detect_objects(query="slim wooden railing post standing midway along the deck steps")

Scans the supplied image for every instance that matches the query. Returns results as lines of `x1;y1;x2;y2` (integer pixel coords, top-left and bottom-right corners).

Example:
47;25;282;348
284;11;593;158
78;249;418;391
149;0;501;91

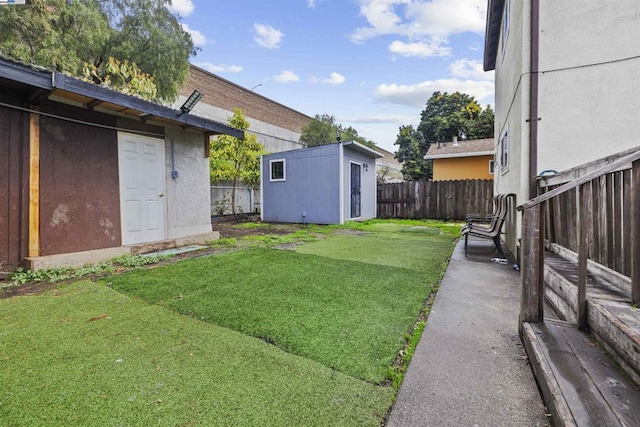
576;182;593;330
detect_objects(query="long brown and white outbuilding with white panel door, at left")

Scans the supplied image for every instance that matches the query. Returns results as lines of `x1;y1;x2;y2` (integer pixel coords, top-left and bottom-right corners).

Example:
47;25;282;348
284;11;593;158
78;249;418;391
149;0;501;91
0;58;244;272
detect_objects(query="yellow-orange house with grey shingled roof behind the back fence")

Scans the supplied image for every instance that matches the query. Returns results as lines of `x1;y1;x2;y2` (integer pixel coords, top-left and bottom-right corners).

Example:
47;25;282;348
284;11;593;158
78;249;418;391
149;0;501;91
424;138;494;181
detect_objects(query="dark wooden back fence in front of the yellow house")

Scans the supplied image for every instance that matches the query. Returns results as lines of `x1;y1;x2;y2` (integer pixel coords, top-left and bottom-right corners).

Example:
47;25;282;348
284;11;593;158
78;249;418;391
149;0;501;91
378;179;493;220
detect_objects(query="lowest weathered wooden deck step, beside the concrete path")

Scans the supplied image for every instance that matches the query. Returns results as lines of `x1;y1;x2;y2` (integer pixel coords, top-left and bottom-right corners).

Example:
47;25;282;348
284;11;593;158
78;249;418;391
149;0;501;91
523;320;640;426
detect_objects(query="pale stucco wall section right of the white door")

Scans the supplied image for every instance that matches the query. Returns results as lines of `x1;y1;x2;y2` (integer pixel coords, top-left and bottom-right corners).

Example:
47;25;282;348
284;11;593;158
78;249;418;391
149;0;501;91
165;126;211;239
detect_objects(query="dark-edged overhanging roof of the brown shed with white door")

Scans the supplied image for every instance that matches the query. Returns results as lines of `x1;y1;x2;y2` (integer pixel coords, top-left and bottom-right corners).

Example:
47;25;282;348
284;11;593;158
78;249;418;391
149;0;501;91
0;56;244;138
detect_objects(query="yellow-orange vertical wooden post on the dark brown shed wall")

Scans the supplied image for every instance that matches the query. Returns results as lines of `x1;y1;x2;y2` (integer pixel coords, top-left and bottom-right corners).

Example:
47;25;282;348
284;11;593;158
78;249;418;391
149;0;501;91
29;107;40;257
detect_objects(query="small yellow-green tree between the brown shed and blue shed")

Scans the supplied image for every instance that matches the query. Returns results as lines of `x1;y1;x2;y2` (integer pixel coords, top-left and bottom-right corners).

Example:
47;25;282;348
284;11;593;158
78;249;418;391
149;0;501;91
209;108;264;219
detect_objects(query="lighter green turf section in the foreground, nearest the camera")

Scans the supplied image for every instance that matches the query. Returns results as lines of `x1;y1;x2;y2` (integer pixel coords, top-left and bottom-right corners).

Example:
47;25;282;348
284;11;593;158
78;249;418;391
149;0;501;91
0;281;392;427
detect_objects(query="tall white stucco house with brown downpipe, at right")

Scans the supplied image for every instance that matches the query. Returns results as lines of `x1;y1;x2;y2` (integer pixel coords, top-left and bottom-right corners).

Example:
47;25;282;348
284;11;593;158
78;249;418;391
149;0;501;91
484;0;640;253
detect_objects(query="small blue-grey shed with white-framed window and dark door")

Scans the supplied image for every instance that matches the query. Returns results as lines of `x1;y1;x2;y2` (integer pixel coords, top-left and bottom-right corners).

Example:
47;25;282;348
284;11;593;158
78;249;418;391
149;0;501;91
260;141;382;224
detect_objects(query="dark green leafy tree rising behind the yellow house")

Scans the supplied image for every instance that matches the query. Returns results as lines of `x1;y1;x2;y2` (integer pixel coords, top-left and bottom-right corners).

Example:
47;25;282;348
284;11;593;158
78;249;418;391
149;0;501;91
396;92;494;180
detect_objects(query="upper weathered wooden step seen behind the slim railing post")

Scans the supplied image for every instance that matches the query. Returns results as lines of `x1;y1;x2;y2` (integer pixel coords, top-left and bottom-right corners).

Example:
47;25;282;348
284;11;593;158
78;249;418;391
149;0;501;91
545;253;640;386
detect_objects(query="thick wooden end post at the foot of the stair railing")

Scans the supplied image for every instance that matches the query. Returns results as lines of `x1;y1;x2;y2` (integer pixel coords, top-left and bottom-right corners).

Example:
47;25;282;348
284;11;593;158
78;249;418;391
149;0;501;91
520;204;544;323
